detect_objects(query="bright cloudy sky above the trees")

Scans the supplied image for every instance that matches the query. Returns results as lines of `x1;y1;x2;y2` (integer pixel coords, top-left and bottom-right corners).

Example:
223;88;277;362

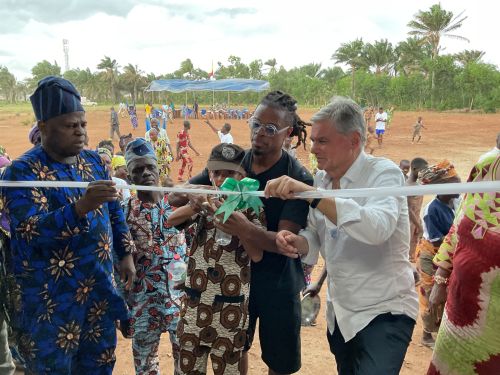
0;0;500;79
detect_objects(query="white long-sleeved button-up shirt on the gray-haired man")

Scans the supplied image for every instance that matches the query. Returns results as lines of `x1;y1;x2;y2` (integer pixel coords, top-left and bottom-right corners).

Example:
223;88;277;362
300;152;418;341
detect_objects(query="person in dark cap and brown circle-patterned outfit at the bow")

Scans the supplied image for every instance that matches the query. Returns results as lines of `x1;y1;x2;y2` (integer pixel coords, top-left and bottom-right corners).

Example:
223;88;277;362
168;143;265;374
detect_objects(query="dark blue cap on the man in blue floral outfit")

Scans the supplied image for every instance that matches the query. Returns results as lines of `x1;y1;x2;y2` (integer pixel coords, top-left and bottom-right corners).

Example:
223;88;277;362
30;76;84;121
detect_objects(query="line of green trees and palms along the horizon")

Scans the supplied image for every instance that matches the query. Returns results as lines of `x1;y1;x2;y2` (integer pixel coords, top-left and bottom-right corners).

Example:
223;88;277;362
0;4;500;112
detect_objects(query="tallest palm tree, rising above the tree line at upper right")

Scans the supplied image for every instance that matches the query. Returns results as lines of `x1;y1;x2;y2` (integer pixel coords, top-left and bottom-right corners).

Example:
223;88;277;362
408;4;469;106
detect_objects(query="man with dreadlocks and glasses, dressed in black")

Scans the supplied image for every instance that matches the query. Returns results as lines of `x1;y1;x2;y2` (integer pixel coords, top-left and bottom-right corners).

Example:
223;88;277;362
170;91;313;375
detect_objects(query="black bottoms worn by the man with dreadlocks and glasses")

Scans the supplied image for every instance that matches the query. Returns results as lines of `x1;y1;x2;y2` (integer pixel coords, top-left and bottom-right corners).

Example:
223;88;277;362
245;289;302;374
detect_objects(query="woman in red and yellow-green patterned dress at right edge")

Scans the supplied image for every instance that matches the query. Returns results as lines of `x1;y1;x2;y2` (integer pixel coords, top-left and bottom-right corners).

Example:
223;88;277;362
427;155;500;375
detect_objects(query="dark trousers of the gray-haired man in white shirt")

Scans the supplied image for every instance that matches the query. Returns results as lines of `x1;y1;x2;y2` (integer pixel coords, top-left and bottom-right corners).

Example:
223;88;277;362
327;313;415;375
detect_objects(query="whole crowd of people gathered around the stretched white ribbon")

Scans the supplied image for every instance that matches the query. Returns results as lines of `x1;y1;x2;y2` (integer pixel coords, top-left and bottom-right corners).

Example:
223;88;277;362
0;77;500;375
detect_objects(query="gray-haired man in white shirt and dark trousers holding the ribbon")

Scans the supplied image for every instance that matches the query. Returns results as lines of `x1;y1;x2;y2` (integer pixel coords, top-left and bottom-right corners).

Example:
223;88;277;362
266;97;418;375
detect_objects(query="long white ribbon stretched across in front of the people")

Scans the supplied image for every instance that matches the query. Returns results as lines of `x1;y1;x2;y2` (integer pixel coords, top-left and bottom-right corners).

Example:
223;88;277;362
0;180;500;198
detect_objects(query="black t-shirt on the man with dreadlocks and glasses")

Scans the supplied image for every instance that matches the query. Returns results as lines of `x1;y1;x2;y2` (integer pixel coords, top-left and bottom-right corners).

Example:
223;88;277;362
189;150;313;294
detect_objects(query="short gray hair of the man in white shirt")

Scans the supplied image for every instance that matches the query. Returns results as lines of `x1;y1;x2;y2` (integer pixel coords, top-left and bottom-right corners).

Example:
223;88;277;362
311;96;366;144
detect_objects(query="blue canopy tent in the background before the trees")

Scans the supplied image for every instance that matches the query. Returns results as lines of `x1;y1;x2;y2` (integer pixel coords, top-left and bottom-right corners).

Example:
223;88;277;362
144;78;270;104
